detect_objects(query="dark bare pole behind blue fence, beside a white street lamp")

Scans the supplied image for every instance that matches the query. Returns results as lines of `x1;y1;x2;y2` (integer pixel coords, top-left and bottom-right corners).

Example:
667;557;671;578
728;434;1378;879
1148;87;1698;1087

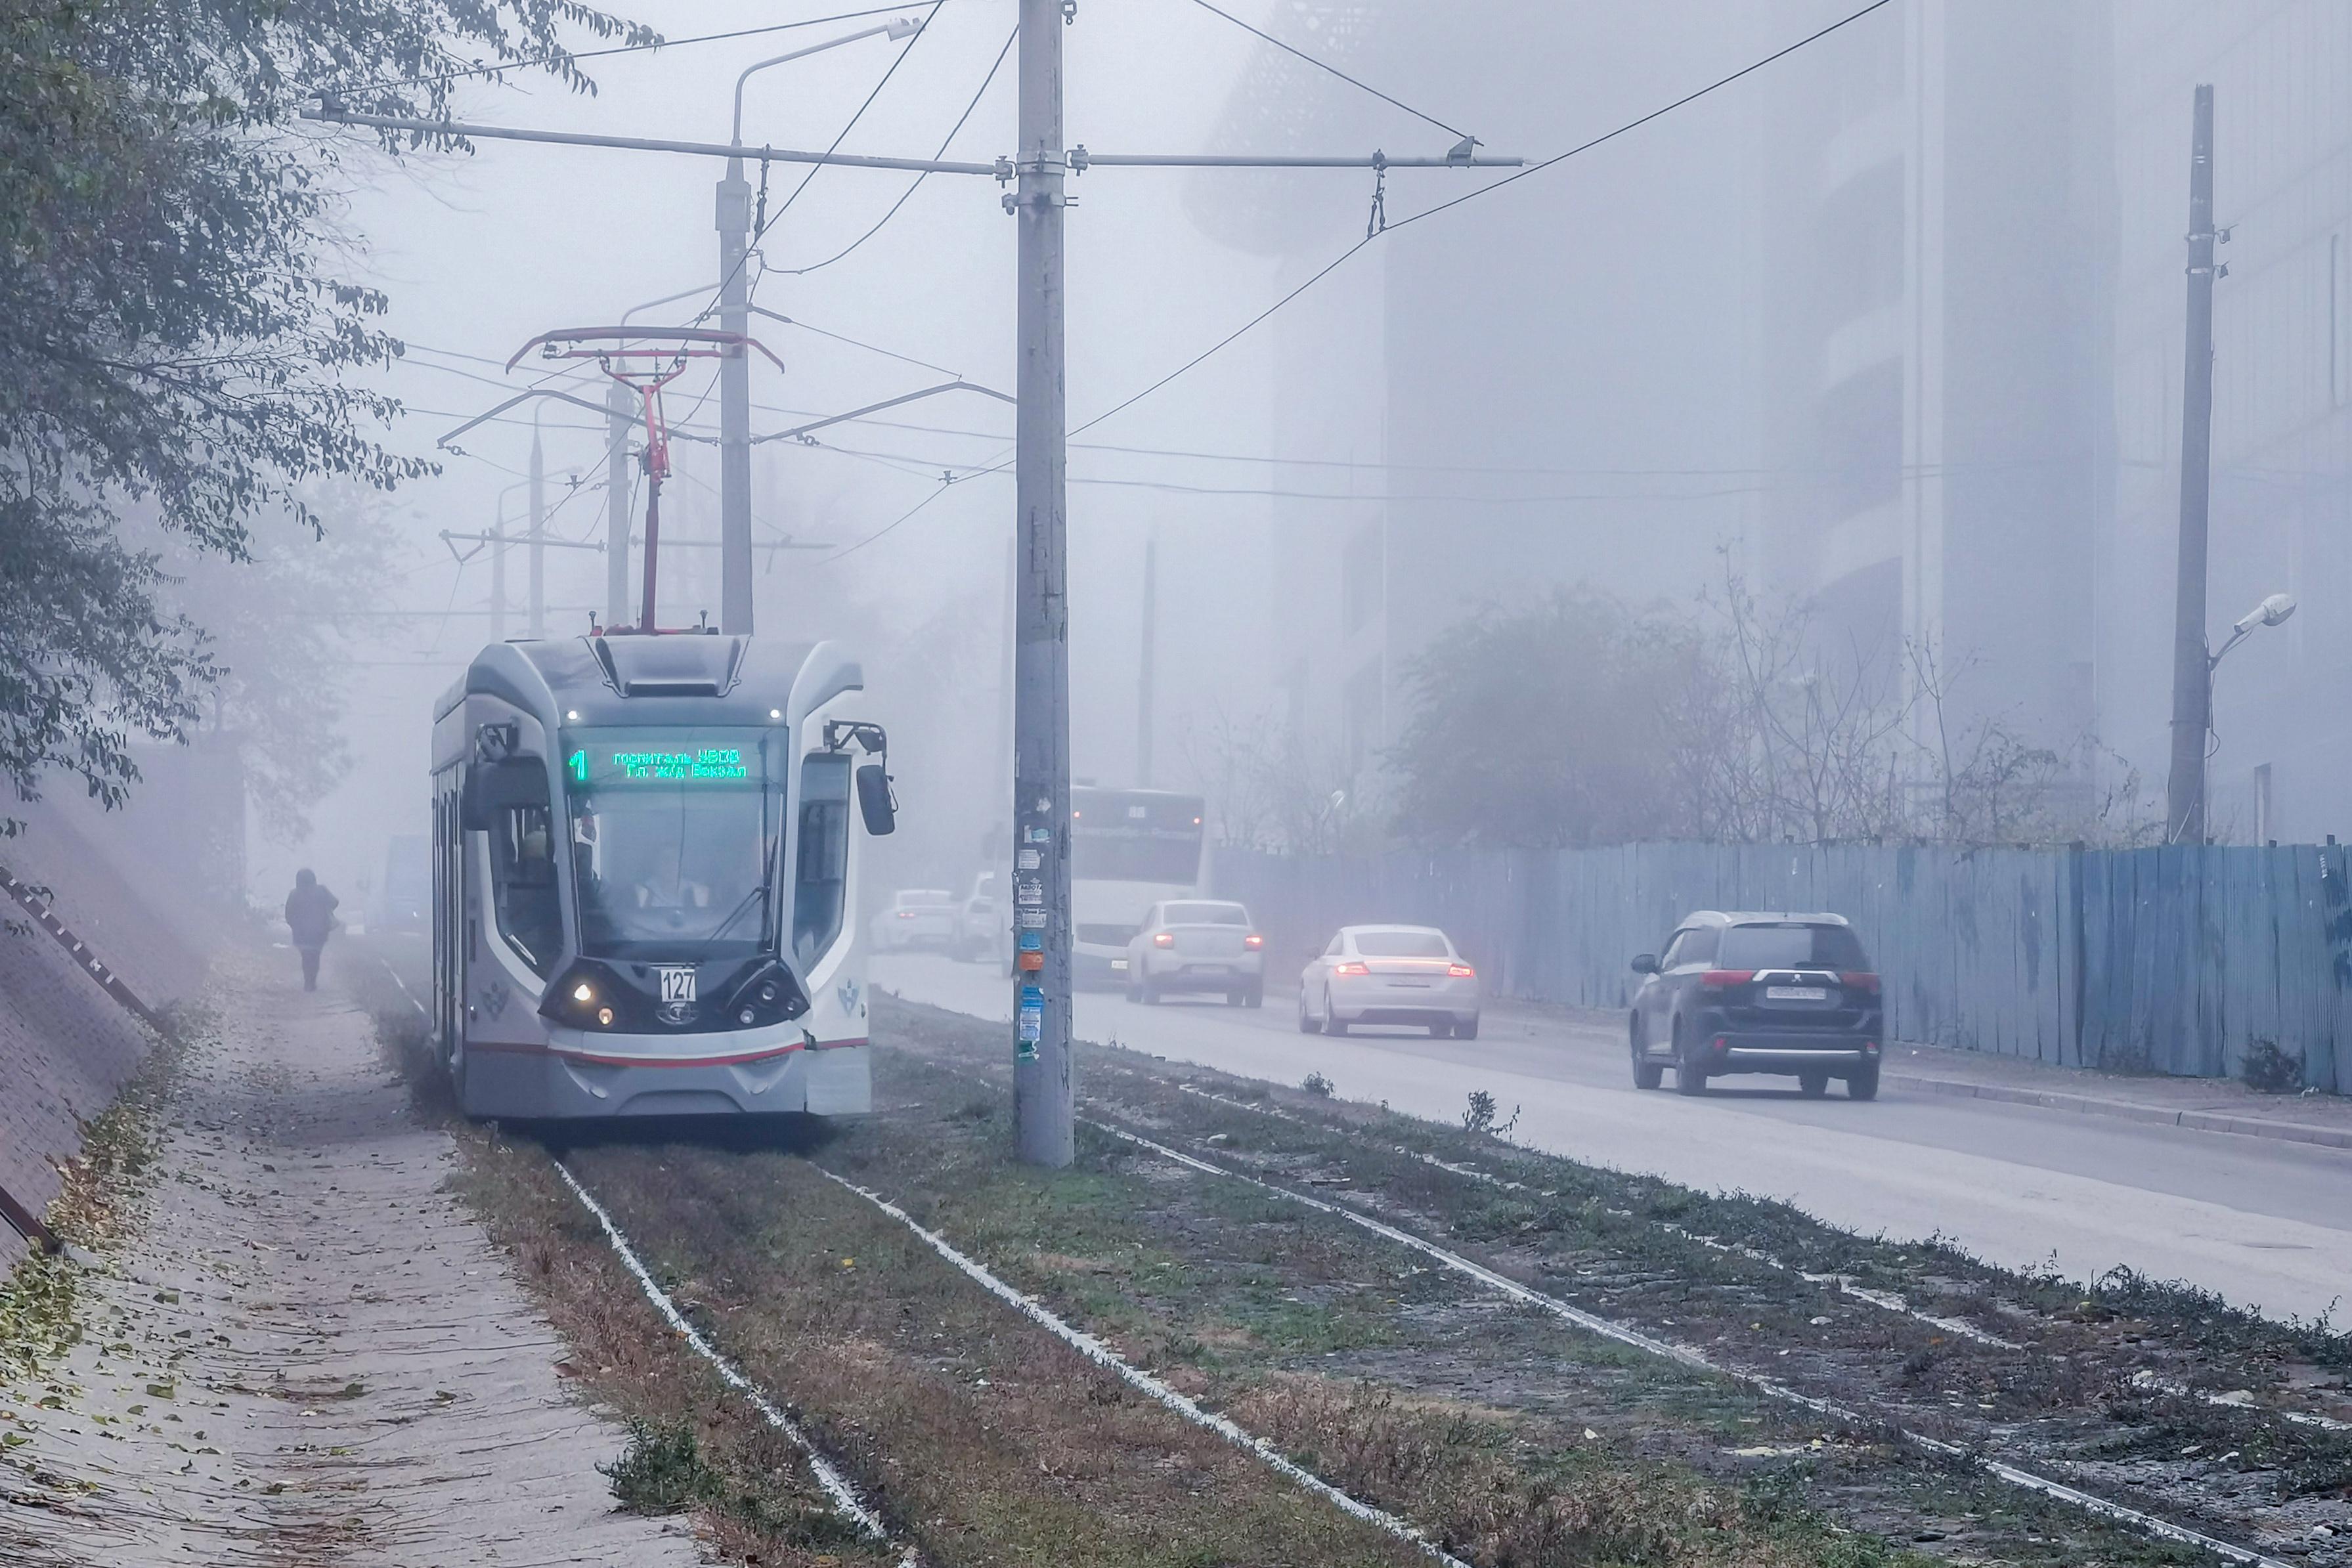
2164;85;2213;844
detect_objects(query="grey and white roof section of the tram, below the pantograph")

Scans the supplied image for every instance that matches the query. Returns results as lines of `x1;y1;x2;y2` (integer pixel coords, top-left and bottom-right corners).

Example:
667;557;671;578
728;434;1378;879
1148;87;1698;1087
433;632;865;724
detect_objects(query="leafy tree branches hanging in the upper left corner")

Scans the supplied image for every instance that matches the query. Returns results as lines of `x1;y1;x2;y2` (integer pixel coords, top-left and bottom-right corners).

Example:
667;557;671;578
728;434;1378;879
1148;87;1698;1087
0;0;649;827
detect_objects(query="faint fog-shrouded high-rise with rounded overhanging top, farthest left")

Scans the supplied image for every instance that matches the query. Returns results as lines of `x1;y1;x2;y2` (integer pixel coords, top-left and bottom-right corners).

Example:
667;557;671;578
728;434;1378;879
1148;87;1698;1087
1188;0;1769;808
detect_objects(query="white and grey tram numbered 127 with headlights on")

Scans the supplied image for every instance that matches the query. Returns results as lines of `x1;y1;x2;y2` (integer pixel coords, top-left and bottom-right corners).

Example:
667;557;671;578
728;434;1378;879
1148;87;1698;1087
433;630;894;1119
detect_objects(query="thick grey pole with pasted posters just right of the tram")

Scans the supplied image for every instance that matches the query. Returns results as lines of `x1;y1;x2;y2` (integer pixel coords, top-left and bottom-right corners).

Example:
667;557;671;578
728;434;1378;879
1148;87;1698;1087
1005;0;1075;1166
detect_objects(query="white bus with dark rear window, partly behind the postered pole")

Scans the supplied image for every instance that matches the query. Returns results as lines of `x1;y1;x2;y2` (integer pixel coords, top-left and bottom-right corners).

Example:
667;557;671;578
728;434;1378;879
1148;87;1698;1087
1070;785;1204;985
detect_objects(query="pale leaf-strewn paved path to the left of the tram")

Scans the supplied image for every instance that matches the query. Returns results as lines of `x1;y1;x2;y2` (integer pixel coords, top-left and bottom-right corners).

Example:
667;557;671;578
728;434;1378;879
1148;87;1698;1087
0;952;701;1568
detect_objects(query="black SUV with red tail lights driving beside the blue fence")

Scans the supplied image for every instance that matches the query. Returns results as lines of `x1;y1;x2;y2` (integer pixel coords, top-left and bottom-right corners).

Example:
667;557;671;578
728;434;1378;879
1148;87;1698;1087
1628;910;1882;1100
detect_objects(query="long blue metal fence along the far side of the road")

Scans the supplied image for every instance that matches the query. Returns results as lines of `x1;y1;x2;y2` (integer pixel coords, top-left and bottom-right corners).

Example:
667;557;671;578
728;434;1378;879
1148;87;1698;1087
1213;844;2352;1093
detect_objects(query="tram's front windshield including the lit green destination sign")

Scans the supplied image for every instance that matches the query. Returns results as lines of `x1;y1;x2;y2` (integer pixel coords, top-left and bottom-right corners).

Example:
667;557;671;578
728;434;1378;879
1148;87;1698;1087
565;726;783;959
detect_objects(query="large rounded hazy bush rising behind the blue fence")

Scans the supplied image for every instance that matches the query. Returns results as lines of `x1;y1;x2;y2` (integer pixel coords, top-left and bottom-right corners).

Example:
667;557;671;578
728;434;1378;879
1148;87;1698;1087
1387;588;1705;848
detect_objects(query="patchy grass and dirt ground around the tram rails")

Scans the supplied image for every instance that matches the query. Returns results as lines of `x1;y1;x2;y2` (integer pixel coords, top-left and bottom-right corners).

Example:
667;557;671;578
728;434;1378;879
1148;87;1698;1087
348;945;2336;1568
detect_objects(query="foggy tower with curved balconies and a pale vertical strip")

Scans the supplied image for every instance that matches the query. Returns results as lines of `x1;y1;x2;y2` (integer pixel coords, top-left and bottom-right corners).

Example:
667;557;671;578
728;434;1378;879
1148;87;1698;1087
1753;0;2112;745
